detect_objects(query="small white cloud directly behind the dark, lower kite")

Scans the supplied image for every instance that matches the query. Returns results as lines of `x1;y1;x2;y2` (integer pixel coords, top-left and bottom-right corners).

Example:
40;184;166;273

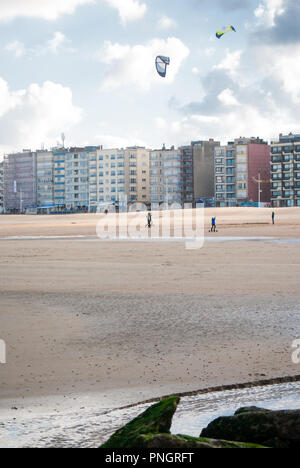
96;37;190;91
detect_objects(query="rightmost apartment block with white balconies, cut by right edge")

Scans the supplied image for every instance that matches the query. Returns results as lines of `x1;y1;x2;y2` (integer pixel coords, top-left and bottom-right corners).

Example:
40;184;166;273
271;133;300;207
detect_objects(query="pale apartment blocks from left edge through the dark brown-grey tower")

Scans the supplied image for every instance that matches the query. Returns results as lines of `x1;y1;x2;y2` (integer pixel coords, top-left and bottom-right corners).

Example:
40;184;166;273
3;140;220;212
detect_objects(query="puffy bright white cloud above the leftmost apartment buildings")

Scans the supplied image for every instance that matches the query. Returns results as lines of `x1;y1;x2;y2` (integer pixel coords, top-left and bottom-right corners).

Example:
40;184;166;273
0;78;83;149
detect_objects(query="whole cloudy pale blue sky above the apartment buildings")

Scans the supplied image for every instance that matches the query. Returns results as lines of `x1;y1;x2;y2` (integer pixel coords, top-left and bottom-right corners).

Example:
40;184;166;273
0;0;300;160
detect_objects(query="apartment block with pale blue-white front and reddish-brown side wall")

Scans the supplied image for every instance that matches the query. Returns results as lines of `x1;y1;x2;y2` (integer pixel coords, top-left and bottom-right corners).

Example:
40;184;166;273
214;138;270;206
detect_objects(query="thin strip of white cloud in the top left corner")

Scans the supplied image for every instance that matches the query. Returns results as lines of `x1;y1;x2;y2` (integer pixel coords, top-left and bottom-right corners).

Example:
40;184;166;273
0;0;95;21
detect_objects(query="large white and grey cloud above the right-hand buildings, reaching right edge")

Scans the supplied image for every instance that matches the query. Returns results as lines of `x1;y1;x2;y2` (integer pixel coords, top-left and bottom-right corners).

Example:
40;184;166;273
171;32;300;143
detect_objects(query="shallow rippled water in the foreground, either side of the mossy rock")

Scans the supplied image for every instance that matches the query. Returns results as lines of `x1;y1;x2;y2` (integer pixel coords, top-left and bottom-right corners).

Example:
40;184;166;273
0;383;300;447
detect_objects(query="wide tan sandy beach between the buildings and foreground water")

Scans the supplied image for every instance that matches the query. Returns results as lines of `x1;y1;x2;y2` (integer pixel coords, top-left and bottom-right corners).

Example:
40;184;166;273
0;208;300;409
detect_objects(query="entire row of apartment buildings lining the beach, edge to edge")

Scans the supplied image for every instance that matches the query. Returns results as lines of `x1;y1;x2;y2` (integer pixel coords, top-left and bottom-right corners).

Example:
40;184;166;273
0;134;300;213
